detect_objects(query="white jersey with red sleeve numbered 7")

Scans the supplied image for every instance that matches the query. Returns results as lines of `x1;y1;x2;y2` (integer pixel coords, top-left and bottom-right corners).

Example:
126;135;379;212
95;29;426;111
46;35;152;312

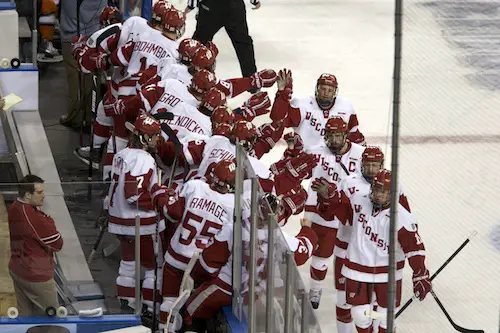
108;148;165;236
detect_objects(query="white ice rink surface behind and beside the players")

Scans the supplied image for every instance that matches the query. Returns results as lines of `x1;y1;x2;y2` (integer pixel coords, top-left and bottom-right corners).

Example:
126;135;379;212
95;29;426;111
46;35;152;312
186;0;500;333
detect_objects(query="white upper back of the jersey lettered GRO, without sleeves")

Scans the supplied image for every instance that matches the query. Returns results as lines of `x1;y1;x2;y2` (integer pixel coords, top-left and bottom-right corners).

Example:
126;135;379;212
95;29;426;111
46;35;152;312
146;79;200;114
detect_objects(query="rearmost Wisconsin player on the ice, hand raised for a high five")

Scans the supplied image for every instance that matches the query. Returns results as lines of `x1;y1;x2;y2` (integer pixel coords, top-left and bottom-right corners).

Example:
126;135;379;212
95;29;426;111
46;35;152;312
271;70;364;152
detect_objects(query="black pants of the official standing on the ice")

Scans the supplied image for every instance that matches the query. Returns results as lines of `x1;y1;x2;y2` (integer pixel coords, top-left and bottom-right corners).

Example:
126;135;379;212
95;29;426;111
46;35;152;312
193;0;257;77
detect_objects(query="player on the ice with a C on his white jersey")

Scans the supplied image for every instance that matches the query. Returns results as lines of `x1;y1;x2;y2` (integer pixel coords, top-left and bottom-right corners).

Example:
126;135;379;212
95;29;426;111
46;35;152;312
304;116;365;308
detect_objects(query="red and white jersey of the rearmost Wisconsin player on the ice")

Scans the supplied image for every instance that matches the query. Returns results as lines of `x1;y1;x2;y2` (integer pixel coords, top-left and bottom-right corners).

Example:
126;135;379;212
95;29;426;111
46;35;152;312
275;96;364;152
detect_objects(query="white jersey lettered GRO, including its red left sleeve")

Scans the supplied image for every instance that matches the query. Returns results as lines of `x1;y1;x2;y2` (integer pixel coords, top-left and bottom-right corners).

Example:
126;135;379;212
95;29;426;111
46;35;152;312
139;79;200;114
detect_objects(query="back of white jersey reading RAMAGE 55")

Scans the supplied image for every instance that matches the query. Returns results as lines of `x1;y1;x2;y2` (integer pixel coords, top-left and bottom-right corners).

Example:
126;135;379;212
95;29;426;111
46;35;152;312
165;179;234;270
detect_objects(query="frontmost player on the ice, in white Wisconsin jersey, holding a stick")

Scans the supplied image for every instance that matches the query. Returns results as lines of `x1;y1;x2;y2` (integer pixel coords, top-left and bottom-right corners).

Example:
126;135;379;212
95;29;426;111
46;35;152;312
318;169;432;333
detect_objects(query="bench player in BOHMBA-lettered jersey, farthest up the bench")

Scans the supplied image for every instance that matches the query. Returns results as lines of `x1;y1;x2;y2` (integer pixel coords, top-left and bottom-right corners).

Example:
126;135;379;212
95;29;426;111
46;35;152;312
75;1;184;179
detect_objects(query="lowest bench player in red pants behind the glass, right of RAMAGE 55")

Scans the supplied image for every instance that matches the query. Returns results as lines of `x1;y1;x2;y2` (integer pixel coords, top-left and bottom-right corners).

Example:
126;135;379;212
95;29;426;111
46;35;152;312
184;193;317;333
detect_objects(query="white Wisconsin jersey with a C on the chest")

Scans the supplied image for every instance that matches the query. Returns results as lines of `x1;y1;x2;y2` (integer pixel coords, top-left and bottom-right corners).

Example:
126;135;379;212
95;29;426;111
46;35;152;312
304;142;365;229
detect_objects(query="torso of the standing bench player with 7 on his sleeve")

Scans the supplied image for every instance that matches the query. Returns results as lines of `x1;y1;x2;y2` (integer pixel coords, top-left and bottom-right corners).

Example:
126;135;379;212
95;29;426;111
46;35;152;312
108;148;157;235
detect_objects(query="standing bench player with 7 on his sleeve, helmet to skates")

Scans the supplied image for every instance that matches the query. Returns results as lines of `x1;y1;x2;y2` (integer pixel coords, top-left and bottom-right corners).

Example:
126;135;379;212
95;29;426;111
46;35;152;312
106;115;172;308
